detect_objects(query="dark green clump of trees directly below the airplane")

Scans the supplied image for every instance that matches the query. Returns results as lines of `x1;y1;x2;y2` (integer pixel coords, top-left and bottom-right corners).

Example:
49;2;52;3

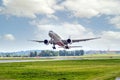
29;50;84;57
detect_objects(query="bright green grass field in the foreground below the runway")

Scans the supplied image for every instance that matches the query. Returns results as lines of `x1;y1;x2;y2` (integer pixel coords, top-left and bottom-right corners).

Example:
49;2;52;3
0;59;120;80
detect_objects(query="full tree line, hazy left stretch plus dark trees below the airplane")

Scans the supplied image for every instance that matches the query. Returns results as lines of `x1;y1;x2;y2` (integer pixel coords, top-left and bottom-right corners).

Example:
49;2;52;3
0;50;84;57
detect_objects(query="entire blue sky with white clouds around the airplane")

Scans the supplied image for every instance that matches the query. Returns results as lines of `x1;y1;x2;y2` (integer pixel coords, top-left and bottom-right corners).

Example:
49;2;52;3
0;0;120;52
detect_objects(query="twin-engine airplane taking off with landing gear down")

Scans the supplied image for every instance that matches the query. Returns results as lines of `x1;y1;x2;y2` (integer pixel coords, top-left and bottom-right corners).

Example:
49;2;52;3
30;31;100;49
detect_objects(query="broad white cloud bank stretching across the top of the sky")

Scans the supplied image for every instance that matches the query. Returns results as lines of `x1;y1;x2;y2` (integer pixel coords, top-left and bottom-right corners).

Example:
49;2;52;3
1;0;120;18
